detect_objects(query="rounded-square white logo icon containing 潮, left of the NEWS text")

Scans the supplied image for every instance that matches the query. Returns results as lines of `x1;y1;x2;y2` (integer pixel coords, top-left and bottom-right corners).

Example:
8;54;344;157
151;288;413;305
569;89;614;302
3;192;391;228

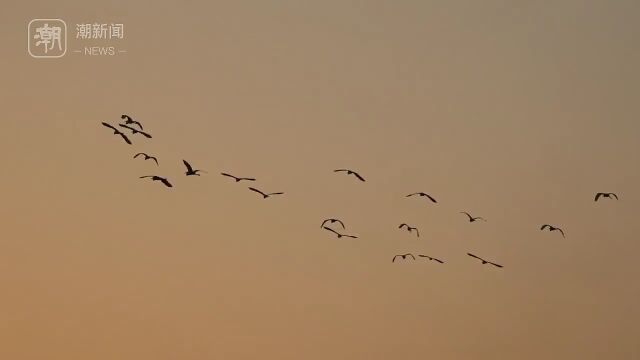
28;19;67;58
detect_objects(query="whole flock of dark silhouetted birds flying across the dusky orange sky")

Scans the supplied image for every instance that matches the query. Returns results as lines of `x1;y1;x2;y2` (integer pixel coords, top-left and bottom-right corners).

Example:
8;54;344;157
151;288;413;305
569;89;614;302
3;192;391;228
102;115;618;268
